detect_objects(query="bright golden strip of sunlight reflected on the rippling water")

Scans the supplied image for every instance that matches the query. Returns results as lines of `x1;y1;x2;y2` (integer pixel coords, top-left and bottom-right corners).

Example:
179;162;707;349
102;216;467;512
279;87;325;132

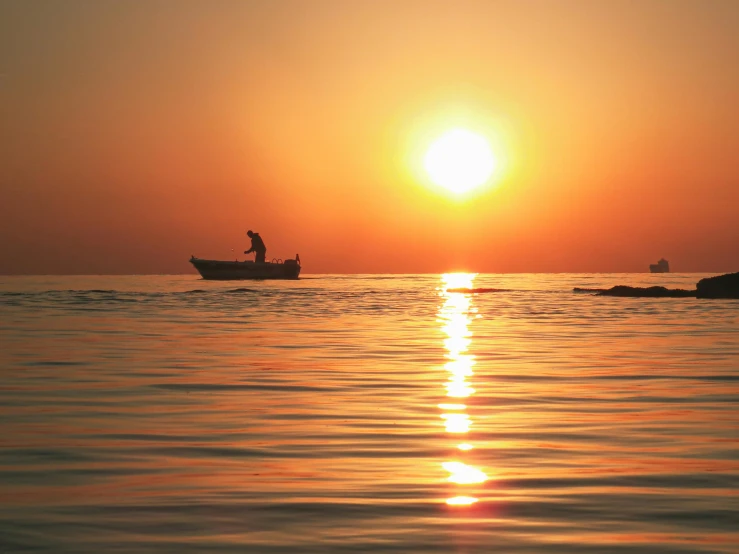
438;273;488;506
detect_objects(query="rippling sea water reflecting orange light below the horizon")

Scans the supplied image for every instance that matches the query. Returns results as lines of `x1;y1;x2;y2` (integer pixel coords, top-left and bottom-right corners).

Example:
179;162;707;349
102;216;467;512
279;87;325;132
0;274;739;554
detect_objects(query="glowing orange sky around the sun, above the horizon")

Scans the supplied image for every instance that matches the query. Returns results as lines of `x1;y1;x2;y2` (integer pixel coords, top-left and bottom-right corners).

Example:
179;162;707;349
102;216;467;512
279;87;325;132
0;0;739;273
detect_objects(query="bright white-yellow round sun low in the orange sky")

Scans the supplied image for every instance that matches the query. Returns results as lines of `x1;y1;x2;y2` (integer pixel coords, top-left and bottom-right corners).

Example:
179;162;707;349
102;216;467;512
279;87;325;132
424;129;496;194
